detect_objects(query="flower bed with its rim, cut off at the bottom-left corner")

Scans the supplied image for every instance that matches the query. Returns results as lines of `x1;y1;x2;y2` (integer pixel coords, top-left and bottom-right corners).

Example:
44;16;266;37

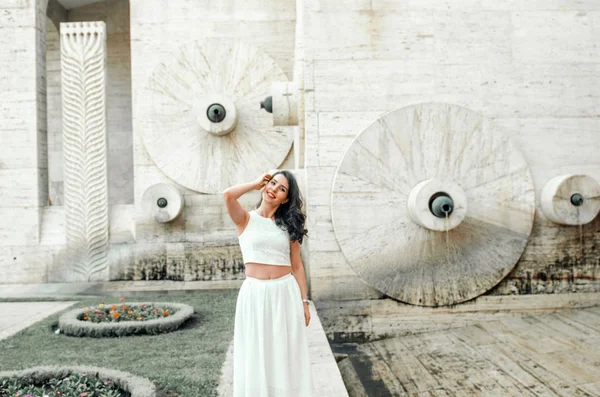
0;366;156;397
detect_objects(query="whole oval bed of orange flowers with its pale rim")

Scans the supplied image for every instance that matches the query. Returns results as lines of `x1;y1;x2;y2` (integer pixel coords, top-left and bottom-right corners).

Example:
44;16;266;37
58;298;194;338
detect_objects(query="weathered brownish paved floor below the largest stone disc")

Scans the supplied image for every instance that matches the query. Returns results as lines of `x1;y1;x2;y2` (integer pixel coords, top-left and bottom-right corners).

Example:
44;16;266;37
334;307;600;397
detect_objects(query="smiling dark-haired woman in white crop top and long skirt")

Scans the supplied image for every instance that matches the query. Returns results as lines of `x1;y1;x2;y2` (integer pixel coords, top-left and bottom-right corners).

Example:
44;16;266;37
223;170;312;397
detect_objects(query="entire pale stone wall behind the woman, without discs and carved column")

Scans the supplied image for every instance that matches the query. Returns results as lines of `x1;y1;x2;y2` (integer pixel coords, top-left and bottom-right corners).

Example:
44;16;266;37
0;0;600;294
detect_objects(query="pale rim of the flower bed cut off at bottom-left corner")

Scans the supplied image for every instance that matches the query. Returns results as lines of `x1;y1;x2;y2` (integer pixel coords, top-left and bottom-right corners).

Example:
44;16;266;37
0;365;156;397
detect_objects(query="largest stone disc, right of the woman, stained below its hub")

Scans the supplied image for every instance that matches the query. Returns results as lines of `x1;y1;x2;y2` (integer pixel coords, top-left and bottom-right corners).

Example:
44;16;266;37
331;103;535;306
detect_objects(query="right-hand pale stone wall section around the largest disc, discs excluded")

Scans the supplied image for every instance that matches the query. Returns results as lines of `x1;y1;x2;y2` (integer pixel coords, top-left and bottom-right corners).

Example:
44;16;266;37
304;0;600;300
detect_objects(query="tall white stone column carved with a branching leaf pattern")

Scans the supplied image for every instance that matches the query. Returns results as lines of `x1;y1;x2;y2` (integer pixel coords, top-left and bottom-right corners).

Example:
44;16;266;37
60;22;108;281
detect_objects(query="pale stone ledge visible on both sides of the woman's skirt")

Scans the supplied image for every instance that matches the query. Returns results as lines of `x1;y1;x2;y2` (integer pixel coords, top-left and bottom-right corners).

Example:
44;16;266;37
218;302;348;397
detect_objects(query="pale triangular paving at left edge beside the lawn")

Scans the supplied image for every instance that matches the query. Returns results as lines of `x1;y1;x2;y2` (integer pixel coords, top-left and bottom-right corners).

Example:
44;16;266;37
0;302;75;340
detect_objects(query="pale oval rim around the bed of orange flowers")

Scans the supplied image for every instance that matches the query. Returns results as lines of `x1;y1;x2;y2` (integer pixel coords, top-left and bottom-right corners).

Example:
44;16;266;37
58;302;194;338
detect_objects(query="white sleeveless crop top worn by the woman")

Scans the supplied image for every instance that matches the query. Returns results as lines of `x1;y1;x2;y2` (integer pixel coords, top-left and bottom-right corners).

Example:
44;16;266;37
238;210;292;266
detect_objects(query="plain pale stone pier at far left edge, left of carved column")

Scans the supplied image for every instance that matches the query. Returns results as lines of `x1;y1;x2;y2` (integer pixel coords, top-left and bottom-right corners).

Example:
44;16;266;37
0;0;48;279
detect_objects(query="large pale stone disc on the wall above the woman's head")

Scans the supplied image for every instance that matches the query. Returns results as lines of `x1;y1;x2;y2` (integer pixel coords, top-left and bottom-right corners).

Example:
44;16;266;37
140;38;293;193
